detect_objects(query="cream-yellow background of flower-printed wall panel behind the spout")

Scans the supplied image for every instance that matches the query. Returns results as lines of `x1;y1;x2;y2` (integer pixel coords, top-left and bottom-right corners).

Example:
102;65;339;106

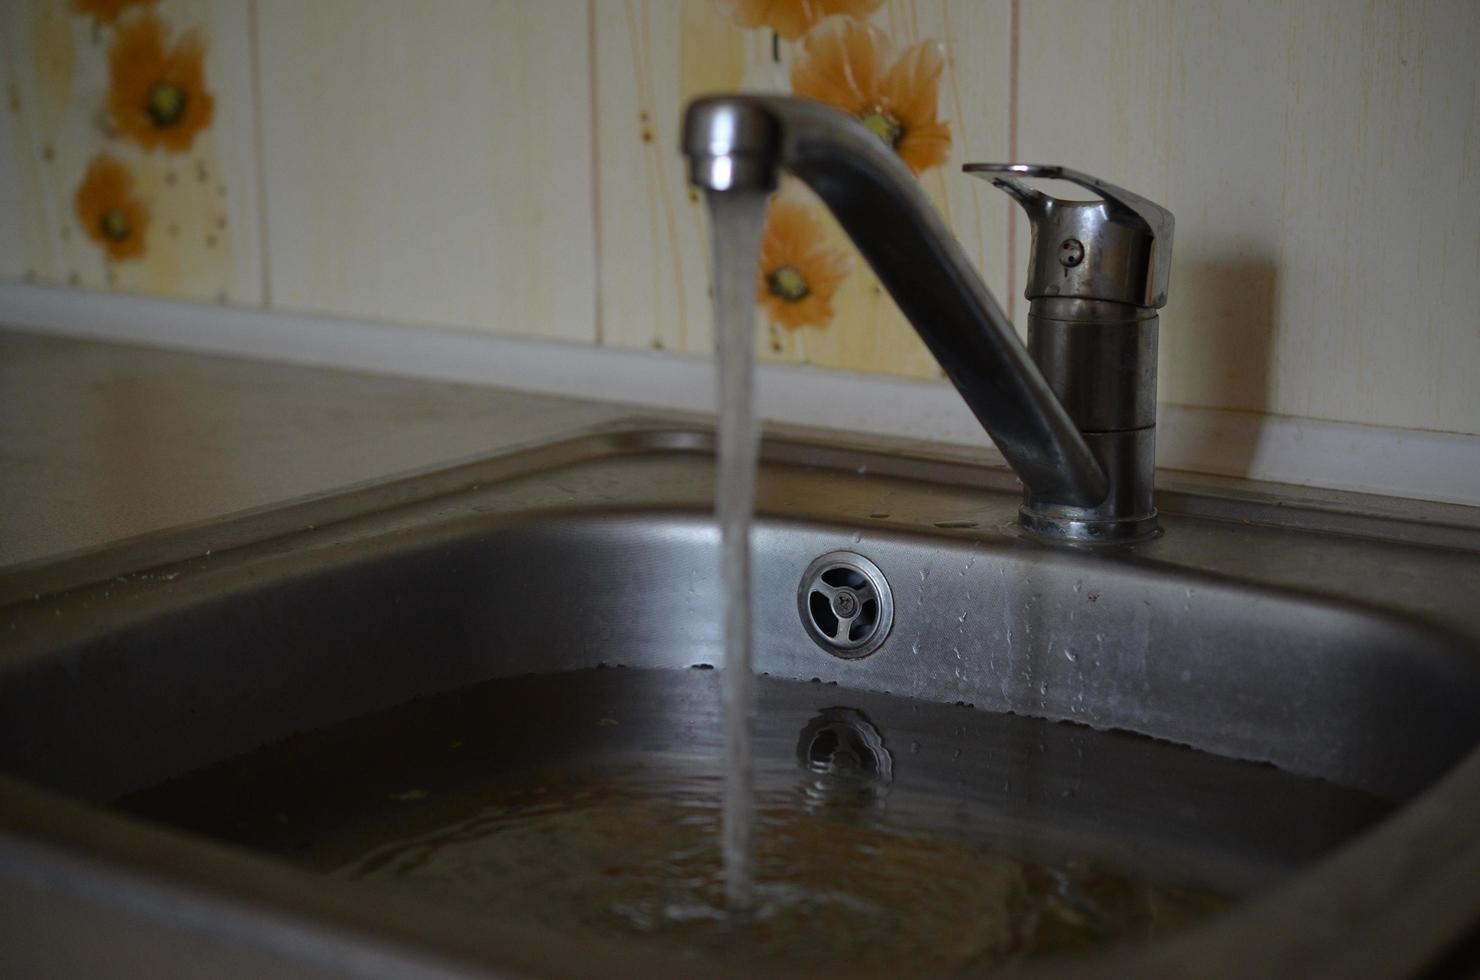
593;0;1011;377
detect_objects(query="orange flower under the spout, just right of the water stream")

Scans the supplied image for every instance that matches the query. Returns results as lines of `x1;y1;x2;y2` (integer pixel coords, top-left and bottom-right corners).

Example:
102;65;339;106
756;195;850;330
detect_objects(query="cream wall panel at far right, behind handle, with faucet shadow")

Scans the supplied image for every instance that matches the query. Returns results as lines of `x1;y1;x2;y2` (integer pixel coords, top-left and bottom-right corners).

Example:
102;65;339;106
1018;0;1480;432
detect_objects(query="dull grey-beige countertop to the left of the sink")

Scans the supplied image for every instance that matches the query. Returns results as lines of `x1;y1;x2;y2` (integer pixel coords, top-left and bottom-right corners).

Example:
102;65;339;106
0;330;635;568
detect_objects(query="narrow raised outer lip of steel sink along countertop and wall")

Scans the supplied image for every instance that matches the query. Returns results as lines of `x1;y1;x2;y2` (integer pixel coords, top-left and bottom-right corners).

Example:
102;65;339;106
0;423;1480;608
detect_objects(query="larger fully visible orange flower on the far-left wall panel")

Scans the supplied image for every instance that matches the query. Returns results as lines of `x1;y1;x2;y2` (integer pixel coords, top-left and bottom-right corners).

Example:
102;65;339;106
108;13;216;152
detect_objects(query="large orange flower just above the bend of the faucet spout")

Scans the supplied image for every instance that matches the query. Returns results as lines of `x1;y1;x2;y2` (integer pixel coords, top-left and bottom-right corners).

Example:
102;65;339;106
792;16;950;173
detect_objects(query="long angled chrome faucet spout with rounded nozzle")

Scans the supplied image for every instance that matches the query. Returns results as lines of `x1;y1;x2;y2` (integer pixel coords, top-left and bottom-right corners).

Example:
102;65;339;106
682;95;1109;529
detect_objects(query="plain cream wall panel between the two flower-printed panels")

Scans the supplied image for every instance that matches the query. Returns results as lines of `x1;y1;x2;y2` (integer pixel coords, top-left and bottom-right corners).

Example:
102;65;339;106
256;0;595;343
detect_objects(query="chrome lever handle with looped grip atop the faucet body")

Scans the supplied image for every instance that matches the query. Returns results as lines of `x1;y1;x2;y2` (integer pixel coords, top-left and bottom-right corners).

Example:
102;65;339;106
962;163;1175;308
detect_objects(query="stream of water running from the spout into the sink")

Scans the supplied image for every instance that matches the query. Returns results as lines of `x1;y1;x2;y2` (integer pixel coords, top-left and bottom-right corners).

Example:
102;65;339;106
707;191;770;912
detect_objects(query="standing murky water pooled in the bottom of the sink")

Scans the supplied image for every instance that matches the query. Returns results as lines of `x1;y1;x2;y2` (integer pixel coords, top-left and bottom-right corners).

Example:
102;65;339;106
120;669;1387;976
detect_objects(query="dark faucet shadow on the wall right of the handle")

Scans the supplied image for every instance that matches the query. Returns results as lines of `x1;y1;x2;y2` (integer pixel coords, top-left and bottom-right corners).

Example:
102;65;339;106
1159;253;1279;477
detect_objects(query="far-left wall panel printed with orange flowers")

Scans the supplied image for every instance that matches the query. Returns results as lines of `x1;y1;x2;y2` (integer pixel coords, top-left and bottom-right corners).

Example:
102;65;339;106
0;0;262;305
